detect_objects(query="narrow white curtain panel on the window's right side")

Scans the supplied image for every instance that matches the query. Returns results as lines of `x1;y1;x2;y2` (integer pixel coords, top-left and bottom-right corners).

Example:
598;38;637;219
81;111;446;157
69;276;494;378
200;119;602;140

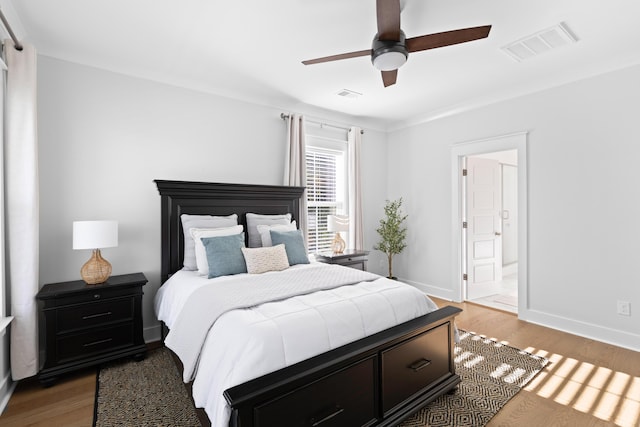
349;126;364;249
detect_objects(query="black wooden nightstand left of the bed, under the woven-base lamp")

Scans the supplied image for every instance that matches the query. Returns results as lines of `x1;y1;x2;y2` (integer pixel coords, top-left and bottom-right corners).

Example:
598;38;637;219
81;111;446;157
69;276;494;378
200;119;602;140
36;273;147;386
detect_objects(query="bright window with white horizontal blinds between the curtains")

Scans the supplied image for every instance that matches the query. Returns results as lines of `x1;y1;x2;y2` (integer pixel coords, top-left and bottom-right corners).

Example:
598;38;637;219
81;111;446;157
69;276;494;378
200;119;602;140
306;135;348;253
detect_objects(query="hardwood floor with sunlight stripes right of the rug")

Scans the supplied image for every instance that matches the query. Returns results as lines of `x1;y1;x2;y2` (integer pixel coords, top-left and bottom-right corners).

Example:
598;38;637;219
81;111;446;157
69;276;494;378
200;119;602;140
434;298;640;427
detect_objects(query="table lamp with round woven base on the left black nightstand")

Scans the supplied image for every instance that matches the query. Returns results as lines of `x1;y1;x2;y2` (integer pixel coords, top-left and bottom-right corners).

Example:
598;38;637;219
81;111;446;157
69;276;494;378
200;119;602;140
73;221;118;285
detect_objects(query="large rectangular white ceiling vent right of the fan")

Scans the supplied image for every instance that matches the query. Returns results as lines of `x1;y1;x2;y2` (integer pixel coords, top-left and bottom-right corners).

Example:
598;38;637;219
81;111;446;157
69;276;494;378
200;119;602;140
502;22;578;61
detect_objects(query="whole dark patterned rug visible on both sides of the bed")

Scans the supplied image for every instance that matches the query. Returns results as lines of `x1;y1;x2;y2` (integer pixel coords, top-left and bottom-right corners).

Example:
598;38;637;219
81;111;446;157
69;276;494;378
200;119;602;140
94;330;548;427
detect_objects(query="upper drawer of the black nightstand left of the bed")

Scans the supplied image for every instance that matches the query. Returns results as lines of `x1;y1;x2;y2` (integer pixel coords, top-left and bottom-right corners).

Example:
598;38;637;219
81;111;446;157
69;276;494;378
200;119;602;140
57;297;134;333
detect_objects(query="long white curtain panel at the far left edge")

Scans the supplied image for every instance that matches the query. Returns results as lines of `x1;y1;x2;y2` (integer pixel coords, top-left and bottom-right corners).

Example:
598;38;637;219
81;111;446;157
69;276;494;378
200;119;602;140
4;40;39;380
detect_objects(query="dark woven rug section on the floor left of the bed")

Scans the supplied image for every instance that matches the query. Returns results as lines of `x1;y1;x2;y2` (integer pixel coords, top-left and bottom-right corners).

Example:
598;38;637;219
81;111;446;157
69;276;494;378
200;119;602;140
93;347;200;427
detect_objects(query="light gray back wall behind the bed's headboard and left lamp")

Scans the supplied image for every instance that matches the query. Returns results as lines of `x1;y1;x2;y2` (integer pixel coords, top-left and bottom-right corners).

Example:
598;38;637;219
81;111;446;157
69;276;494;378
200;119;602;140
38;56;387;340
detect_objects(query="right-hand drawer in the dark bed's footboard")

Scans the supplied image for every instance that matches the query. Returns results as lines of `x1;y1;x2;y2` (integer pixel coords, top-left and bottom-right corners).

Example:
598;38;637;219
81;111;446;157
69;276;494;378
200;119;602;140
382;324;449;413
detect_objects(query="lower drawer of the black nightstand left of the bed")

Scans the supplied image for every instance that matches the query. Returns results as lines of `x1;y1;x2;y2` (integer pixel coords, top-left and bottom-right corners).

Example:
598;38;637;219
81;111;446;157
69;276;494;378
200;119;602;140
57;323;133;363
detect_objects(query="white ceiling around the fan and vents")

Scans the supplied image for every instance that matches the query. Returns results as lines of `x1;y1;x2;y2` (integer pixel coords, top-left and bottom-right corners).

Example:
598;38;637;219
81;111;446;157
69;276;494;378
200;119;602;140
2;0;640;129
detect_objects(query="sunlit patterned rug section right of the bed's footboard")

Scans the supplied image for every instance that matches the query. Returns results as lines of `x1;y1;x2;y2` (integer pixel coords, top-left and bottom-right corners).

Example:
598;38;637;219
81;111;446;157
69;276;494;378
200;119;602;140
400;330;549;427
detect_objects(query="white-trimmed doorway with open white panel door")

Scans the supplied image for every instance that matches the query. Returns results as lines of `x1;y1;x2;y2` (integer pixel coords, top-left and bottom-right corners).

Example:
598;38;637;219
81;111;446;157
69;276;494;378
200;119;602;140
452;133;528;314
